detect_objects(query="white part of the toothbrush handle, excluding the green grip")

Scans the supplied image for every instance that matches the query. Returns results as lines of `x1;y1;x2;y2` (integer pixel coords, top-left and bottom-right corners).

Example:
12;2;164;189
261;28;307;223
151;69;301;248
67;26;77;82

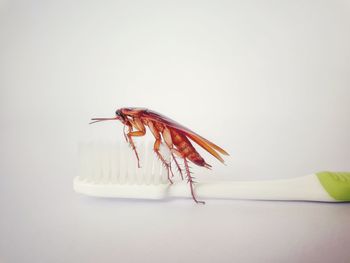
171;174;335;202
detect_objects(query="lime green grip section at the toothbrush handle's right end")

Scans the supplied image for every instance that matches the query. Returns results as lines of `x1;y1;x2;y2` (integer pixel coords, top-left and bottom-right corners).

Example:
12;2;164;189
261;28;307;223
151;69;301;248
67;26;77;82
316;172;350;202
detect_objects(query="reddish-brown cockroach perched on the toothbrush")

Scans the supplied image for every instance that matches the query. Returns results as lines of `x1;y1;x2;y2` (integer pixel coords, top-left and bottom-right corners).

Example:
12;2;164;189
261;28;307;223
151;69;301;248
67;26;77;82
90;108;229;204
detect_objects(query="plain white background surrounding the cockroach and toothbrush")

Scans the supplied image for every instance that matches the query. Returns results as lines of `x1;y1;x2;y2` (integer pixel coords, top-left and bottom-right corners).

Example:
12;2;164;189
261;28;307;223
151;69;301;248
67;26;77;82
0;0;350;263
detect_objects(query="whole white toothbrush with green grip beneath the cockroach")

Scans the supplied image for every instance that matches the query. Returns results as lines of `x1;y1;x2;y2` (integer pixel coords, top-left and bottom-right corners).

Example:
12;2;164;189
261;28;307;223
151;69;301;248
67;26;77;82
73;143;350;202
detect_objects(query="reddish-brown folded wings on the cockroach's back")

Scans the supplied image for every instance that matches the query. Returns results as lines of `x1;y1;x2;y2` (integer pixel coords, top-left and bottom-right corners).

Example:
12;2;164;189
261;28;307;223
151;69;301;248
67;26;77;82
142;110;229;163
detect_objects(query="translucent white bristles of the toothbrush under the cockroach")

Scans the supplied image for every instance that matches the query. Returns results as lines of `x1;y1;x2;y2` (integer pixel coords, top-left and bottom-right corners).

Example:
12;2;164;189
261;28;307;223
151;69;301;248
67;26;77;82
78;142;170;185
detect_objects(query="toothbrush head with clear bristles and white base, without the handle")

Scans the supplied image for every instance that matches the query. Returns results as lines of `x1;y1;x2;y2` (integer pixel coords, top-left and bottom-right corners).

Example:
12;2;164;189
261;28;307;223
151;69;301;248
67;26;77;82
74;142;170;199
